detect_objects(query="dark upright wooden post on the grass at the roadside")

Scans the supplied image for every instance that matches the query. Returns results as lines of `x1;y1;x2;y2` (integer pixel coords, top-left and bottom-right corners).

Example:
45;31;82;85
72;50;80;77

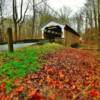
7;28;13;52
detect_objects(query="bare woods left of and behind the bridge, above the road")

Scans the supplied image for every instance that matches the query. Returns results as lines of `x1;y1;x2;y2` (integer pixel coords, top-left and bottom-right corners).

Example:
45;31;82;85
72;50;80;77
0;0;71;41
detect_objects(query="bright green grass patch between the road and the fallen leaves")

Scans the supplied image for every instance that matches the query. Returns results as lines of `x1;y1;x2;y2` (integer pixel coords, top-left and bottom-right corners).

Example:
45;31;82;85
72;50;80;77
0;43;62;81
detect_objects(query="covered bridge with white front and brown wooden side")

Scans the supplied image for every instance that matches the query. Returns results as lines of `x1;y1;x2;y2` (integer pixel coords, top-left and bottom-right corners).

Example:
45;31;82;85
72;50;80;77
41;21;80;47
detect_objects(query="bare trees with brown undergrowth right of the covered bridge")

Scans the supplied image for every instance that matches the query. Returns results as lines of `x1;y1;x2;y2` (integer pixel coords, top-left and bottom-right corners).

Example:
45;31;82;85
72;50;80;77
66;0;100;48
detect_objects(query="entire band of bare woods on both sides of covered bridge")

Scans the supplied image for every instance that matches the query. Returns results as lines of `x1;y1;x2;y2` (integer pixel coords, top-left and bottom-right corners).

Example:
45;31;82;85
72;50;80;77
0;0;100;47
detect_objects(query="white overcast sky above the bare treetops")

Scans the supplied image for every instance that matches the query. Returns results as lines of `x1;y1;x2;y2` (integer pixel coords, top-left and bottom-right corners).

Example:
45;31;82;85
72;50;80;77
48;0;86;12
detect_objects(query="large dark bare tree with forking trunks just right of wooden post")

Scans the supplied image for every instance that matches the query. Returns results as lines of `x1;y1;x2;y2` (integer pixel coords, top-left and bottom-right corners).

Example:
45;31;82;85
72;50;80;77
13;0;30;41
